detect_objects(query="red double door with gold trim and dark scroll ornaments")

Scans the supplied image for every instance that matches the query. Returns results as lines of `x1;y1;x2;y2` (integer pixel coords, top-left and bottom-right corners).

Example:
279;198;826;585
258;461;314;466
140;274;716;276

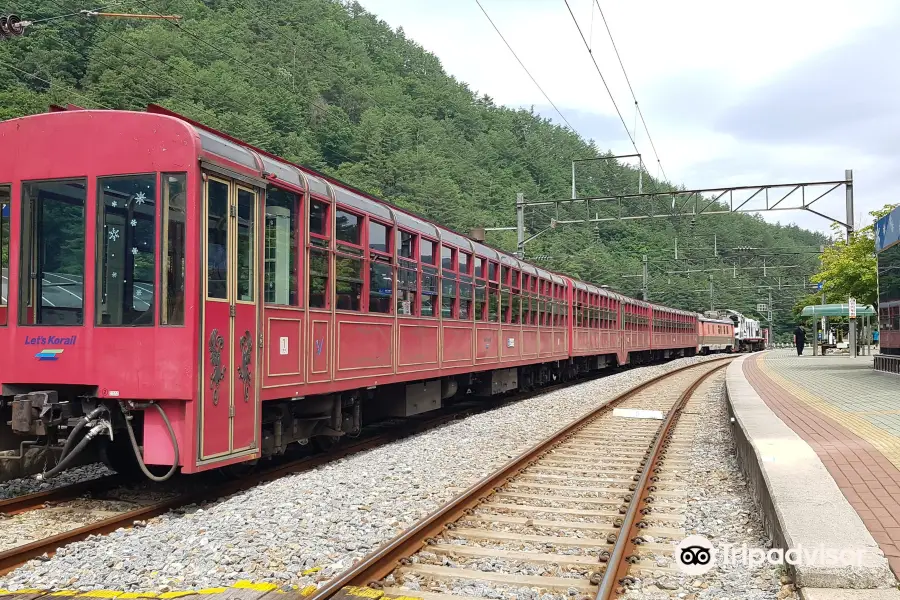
200;175;259;461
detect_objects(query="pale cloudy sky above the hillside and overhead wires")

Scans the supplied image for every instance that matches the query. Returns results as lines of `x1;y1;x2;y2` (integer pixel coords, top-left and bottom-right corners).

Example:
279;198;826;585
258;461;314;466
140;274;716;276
361;0;900;238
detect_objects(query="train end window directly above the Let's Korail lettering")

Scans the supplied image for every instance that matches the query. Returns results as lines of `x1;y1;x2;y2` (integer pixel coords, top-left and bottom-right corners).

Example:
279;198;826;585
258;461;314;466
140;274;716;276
19;179;87;325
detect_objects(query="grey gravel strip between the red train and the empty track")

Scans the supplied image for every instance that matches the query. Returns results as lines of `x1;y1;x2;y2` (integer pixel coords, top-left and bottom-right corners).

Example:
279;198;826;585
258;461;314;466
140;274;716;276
0;357;720;592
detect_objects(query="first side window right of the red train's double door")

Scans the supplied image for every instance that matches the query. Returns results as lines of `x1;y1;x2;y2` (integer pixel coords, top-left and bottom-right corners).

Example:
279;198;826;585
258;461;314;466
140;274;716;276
263;186;300;306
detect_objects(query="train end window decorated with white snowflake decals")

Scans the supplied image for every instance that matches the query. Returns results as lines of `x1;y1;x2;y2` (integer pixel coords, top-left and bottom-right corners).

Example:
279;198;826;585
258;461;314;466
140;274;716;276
96;174;156;326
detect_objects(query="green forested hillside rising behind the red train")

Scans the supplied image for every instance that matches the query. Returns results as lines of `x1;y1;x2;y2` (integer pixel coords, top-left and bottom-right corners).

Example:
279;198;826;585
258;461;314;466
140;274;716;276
0;0;823;332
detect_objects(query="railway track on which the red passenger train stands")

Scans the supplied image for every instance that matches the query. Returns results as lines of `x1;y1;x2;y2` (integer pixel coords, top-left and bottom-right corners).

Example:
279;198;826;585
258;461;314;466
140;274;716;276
0;356;704;575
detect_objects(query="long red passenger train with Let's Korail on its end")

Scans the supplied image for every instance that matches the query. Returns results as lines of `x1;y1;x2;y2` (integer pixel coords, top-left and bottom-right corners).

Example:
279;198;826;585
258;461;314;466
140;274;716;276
0;106;716;478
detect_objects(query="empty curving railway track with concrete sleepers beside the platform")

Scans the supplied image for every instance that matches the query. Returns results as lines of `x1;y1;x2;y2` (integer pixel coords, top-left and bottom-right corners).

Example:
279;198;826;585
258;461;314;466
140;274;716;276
310;360;728;600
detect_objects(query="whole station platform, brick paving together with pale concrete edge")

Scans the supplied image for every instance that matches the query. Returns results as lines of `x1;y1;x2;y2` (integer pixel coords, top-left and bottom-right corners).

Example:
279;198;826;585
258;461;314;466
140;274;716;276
728;348;900;588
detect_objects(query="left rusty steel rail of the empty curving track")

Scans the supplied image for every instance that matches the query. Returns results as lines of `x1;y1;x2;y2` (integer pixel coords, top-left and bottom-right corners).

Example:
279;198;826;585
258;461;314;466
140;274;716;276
306;355;733;600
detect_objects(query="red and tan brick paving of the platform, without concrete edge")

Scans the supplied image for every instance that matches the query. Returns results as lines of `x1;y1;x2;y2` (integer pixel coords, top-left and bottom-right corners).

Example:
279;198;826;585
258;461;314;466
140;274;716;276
743;350;900;577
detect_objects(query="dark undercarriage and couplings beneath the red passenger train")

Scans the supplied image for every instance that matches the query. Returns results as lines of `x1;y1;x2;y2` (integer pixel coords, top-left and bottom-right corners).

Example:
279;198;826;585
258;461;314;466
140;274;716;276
0;349;694;481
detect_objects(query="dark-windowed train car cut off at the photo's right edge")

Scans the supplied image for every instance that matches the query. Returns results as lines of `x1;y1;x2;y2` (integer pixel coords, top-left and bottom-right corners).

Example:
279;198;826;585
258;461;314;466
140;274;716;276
875;207;900;364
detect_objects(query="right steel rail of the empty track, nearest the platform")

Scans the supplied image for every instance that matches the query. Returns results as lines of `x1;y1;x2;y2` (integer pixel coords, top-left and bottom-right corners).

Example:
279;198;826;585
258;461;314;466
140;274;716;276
596;365;727;600
